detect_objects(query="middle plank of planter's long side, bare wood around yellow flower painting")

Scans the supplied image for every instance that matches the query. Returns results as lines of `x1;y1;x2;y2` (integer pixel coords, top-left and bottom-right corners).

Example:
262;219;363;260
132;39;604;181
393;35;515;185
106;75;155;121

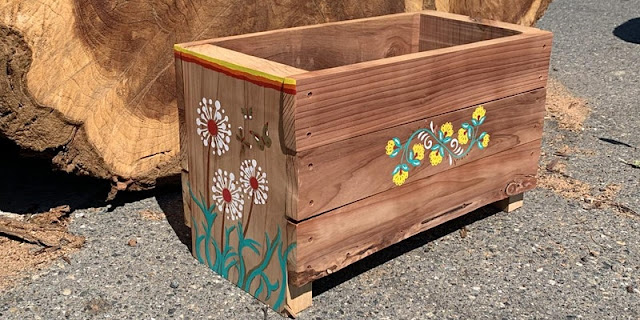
289;89;545;221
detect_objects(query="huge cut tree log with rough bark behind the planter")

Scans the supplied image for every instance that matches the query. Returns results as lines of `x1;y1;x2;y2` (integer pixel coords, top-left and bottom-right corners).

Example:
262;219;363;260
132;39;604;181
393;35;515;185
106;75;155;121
0;0;550;195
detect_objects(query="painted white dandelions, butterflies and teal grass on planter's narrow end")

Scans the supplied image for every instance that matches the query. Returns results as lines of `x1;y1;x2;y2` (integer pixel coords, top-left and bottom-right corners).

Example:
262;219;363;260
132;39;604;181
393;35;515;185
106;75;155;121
189;98;295;311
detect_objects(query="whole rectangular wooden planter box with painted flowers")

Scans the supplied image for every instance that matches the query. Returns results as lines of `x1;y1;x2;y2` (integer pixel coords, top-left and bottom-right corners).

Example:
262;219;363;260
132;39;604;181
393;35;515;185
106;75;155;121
175;12;551;314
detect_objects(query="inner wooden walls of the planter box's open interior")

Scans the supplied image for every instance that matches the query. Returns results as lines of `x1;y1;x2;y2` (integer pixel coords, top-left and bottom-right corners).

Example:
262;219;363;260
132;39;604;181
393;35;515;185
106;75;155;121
212;14;519;71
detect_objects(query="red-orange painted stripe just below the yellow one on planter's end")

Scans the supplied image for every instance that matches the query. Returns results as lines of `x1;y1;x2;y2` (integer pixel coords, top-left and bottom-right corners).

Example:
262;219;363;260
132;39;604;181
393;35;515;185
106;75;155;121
174;50;296;94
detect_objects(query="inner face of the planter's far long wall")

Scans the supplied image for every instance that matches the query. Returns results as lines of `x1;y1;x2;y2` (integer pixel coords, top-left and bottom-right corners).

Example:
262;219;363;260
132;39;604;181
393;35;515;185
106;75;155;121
214;13;419;70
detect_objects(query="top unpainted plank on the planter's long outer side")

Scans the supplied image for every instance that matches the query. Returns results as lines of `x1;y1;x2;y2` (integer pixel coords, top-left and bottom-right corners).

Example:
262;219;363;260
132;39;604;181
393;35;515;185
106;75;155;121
293;32;551;151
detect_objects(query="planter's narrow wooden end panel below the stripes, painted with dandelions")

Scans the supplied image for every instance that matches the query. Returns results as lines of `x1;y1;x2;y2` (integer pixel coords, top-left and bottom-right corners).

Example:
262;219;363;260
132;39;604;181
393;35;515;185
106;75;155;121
178;55;297;311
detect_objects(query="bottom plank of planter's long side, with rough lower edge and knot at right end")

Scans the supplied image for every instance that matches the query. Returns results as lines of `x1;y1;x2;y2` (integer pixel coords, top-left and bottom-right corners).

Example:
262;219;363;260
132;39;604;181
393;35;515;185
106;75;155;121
289;140;541;286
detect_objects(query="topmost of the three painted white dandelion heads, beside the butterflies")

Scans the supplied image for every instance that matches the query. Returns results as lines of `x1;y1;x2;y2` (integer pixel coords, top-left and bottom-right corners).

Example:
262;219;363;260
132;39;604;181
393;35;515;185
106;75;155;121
196;98;231;156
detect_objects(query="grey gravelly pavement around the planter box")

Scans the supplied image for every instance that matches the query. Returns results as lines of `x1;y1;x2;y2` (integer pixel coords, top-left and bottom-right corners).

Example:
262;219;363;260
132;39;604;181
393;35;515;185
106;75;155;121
0;0;640;319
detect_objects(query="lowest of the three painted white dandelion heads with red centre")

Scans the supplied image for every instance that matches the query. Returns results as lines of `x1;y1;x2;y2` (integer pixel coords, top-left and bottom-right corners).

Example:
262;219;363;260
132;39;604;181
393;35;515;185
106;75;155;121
211;169;244;220
